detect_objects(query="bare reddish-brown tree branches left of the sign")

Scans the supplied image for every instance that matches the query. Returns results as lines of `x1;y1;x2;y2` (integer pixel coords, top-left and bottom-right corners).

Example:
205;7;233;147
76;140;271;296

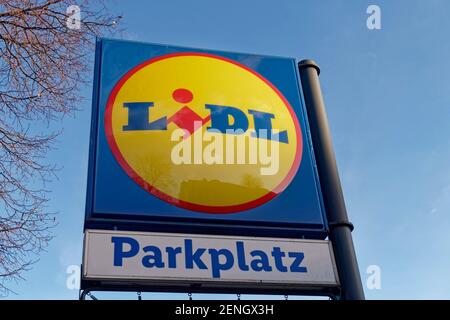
0;0;120;295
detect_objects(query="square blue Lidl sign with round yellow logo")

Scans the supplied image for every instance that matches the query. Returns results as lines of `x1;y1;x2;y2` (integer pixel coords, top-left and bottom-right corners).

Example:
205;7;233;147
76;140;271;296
86;39;326;238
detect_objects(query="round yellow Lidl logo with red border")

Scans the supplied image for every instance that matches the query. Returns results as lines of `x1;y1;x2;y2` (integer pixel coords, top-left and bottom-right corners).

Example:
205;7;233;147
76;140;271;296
104;52;303;213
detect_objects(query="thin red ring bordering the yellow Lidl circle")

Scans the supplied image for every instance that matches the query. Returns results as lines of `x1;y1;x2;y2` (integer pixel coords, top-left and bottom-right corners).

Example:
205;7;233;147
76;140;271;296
104;52;303;214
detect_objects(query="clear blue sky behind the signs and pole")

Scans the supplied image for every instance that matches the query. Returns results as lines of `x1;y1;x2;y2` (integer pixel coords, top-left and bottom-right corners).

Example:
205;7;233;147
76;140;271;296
3;0;450;299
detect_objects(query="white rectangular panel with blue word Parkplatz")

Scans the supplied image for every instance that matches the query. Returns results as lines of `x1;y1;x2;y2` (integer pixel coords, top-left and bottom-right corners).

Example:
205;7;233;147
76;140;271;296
83;230;338;287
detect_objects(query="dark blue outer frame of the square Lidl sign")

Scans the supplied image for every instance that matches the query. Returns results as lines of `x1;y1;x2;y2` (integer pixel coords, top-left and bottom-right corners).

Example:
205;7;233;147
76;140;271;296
84;39;328;239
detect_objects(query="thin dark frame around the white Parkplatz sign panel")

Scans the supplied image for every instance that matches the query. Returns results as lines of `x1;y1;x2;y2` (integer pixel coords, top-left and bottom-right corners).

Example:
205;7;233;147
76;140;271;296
81;230;340;295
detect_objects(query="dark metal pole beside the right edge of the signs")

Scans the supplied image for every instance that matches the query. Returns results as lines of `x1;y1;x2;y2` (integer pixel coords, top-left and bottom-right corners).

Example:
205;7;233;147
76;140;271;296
298;60;364;300
